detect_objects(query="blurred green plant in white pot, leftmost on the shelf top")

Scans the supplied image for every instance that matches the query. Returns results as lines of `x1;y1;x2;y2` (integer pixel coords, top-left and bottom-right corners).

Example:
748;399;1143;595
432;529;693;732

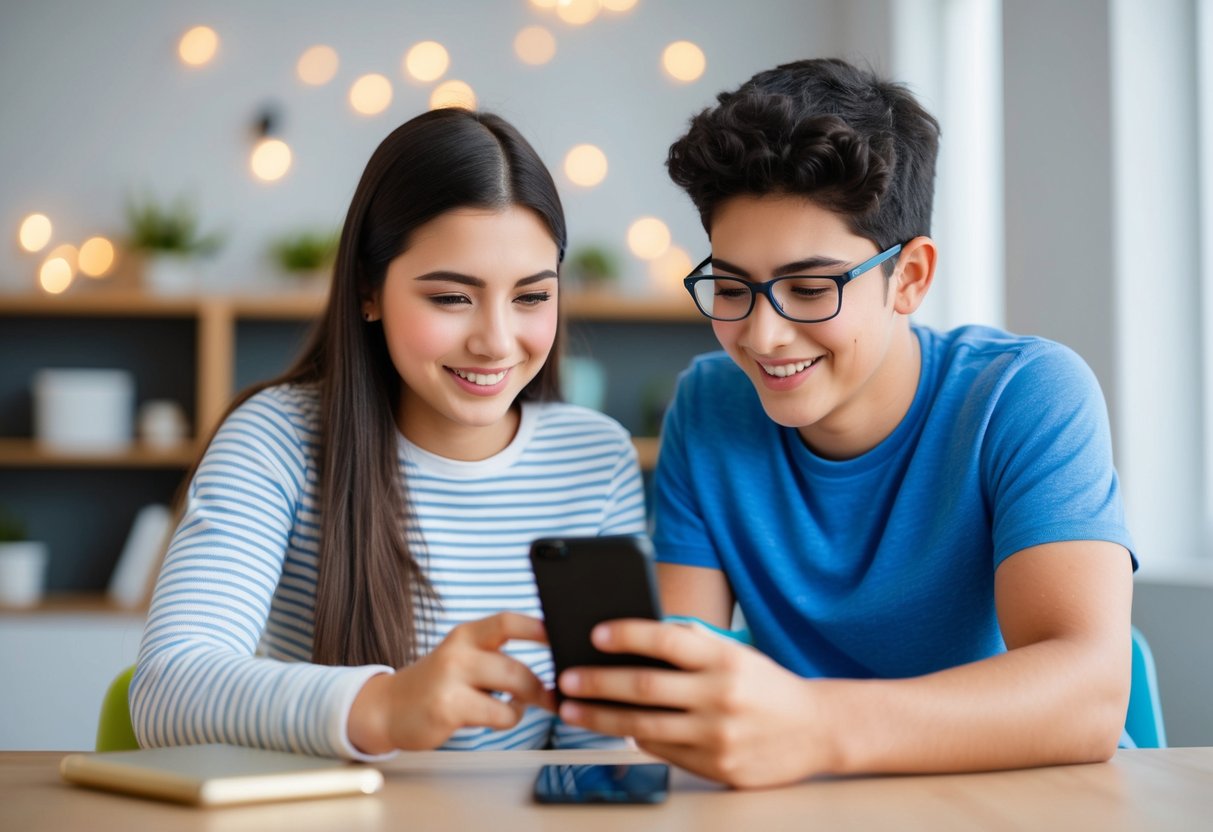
126;196;222;294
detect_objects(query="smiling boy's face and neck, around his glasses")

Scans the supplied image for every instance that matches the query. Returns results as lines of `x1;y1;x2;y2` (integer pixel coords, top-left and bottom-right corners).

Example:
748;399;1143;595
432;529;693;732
711;195;918;458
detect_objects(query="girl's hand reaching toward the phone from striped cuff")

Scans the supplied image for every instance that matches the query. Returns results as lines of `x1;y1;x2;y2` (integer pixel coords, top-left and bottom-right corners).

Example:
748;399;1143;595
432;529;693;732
348;612;554;754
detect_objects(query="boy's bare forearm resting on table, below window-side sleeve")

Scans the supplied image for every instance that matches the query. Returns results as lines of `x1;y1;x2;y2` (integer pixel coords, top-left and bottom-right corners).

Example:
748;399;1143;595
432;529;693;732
808;638;1129;774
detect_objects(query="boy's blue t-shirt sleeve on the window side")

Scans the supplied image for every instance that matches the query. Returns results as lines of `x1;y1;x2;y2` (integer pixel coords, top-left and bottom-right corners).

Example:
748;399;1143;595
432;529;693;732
981;342;1137;568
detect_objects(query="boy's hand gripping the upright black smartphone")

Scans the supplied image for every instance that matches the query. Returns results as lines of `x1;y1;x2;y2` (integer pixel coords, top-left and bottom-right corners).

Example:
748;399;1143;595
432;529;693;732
557;620;835;787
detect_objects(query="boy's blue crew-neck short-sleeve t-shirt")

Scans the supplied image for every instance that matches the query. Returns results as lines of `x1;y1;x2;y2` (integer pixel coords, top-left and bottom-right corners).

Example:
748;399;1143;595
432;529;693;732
654;326;1135;678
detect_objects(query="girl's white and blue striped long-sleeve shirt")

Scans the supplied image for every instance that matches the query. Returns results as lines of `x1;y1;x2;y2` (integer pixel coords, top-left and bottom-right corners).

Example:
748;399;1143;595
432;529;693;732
130;386;644;758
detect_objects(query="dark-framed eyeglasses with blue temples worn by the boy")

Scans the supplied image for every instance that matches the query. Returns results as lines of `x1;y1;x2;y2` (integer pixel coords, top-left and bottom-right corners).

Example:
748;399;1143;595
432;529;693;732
683;243;901;324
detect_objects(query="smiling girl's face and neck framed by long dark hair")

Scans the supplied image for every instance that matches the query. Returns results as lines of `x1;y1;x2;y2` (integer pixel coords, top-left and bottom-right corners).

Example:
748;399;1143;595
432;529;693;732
364;206;559;460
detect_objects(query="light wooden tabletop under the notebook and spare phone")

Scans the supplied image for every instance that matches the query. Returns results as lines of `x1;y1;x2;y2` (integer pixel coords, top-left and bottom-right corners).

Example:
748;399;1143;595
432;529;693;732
0;748;1213;832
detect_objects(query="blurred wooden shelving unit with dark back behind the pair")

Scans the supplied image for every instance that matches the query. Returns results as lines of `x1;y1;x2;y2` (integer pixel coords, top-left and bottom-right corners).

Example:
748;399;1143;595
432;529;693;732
0;291;716;611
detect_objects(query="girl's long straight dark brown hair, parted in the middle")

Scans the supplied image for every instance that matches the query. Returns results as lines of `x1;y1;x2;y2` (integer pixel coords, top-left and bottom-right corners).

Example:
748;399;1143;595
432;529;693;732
190;108;566;667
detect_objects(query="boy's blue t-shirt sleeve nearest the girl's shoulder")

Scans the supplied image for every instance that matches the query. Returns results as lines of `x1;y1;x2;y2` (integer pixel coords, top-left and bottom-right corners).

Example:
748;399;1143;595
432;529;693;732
653;367;721;569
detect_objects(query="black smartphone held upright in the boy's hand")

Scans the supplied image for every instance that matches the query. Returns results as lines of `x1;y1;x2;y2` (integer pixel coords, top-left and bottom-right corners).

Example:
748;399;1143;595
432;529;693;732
530;535;673;705
